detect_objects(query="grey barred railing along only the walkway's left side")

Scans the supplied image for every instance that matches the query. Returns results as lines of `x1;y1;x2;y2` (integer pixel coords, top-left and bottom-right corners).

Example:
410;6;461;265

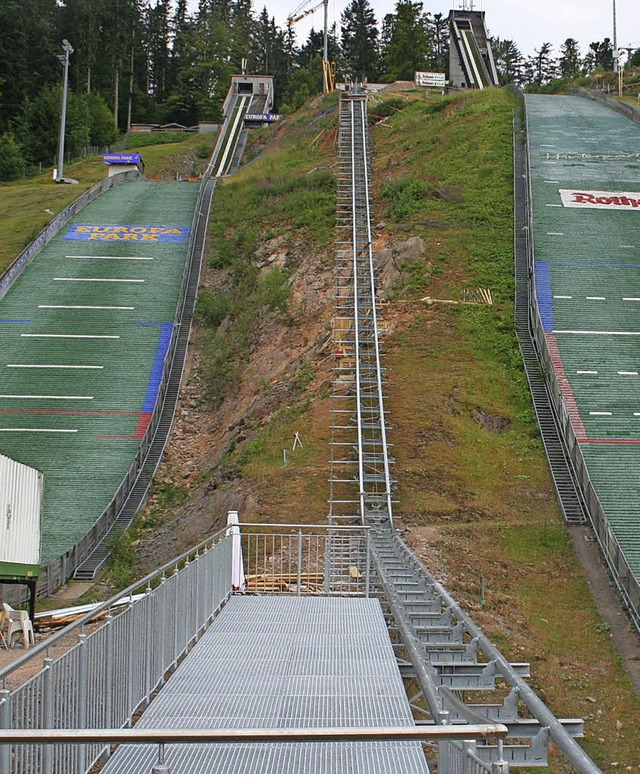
0;529;232;774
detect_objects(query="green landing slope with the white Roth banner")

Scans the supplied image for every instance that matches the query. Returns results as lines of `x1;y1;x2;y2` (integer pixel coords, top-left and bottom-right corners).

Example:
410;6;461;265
526;95;640;579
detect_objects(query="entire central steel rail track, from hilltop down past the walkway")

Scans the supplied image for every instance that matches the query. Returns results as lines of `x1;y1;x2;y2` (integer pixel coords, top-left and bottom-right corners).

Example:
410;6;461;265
330;88;600;774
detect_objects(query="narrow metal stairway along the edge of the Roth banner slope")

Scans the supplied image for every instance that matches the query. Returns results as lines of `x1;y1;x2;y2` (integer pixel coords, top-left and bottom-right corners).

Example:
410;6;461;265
513;116;587;525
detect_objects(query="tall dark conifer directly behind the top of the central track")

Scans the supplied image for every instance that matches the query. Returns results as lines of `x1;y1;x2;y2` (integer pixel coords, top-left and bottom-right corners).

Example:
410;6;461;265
342;0;378;81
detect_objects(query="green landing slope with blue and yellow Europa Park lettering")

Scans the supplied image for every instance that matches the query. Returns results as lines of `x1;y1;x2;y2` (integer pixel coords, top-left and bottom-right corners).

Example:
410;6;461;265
0;182;199;564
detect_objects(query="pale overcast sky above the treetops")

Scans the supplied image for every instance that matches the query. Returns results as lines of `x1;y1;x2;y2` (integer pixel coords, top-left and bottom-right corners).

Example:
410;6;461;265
190;0;640;55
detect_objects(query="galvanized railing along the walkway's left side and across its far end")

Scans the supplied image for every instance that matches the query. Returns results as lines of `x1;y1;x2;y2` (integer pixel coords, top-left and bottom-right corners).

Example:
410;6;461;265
0;524;376;774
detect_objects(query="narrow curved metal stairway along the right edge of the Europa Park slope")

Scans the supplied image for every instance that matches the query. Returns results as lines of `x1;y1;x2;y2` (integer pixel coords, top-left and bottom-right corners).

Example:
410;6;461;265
73;178;216;580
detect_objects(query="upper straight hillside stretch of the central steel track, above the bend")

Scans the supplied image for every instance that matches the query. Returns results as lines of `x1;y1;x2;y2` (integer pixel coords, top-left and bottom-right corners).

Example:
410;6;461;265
330;94;392;522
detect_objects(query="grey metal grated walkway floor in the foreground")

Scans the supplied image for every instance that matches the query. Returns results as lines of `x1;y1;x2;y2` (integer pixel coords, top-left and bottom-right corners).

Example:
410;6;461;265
103;596;428;774
